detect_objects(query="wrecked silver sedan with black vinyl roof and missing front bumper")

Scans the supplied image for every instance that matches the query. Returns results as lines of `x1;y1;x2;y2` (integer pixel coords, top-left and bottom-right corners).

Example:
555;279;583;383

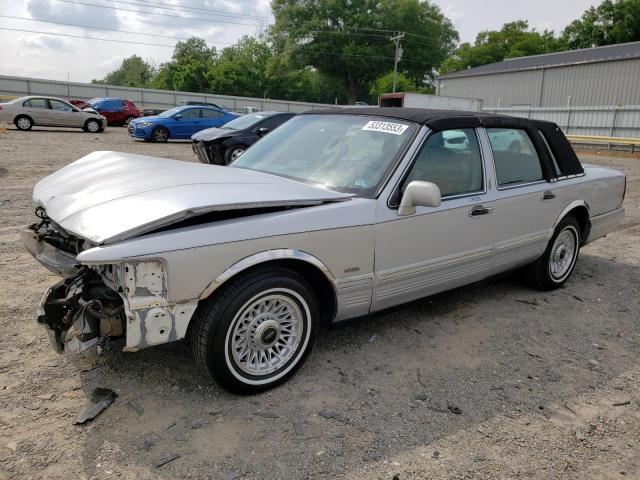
23;108;626;393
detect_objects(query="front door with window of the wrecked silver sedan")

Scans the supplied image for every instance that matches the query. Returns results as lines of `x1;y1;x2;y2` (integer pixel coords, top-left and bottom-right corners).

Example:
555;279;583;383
372;129;495;310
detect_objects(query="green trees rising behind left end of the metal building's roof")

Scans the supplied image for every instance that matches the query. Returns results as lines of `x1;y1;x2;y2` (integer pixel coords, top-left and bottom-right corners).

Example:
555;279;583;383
440;20;564;74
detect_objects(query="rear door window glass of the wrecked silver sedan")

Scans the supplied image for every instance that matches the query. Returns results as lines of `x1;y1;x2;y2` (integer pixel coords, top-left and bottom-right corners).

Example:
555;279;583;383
487;128;543;187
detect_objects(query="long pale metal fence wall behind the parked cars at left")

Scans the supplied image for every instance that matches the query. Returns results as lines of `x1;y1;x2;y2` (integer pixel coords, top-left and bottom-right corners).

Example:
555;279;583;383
0;75;331;112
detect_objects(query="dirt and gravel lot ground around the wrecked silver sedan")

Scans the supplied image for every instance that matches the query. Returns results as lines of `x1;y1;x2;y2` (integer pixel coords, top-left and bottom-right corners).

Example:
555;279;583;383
0;128;640;480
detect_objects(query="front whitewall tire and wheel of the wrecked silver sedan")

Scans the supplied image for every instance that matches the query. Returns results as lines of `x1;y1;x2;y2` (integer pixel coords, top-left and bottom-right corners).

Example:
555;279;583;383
188;267;319;395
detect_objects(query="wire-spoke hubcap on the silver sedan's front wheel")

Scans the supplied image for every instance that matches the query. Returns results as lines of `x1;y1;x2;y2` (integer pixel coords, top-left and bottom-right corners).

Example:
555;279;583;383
231;293;303;375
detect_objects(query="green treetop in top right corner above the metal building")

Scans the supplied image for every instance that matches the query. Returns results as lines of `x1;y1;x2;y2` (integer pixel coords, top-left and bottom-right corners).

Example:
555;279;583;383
562;0;640;49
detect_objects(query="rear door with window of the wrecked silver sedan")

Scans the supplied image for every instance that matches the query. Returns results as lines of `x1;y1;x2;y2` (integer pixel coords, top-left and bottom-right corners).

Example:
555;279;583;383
486;128;562;273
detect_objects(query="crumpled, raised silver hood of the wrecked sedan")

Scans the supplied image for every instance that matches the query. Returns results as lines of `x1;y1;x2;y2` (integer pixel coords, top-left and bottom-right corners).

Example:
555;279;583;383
33;152;352;244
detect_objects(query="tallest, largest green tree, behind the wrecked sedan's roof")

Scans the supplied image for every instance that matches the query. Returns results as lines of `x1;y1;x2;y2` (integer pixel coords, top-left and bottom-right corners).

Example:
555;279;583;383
270;0;458;103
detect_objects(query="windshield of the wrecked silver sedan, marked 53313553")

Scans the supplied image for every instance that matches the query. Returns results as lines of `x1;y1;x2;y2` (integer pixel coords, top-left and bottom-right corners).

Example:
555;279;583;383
231;114;416;196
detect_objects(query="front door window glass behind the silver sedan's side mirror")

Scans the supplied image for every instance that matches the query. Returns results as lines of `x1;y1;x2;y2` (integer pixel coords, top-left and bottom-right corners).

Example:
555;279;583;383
402;128;484;198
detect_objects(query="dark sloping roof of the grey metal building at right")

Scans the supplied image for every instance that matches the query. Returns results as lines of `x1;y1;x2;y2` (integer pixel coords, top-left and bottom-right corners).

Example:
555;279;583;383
440;42;640;80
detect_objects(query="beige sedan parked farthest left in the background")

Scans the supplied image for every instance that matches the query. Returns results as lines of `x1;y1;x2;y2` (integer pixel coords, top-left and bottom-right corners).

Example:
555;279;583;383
0;96;107;133
